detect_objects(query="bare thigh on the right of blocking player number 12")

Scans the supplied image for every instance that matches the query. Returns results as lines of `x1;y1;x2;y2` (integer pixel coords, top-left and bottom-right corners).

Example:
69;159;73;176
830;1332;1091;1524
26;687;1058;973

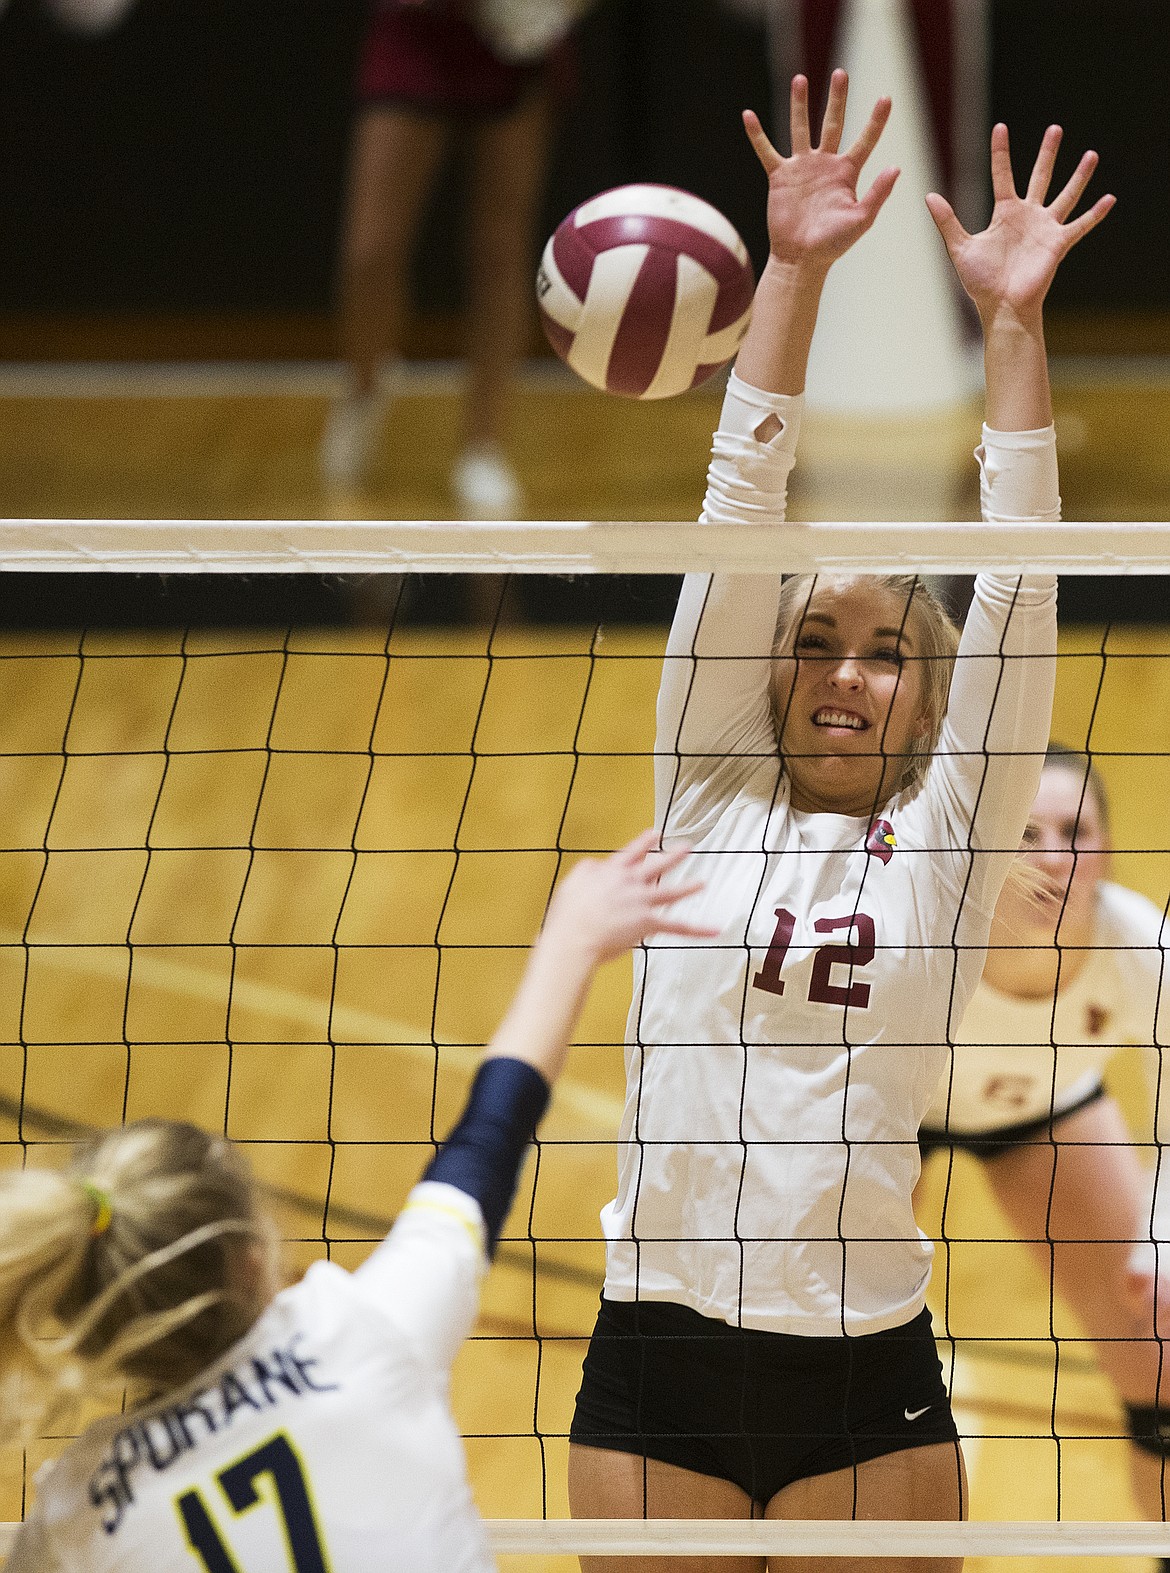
764;1442;967;1573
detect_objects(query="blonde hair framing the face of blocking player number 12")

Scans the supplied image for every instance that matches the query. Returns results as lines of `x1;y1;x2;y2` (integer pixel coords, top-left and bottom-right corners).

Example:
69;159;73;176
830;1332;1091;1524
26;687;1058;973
769;574;959;807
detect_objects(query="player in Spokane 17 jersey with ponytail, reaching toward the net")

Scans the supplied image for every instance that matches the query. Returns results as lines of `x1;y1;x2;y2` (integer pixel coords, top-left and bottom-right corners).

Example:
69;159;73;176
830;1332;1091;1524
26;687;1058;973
0;831;711;1573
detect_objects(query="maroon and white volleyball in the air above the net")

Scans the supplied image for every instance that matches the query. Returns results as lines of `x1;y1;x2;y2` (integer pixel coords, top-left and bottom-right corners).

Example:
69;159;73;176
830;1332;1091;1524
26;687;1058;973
536;186;755;398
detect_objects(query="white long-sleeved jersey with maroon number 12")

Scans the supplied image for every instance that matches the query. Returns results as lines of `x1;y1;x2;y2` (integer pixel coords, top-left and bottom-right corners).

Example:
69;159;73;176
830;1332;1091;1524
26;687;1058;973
602;376;1060;1335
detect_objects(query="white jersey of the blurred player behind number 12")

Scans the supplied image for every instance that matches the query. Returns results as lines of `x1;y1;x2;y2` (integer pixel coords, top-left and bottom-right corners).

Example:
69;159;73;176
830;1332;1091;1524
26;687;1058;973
923;881;1170;1134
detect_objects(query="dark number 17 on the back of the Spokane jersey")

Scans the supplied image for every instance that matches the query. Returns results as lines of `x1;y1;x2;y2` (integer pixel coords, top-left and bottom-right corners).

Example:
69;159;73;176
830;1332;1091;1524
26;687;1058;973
175;1431;329;1573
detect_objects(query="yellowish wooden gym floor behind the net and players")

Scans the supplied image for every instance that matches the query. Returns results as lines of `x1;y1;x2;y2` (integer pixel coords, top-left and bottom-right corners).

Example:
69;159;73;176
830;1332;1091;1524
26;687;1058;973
0;361;1170;1573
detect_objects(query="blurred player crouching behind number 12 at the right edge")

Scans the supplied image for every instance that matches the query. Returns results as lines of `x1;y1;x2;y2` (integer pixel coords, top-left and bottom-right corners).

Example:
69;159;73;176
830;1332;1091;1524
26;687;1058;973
920;746;1170;1541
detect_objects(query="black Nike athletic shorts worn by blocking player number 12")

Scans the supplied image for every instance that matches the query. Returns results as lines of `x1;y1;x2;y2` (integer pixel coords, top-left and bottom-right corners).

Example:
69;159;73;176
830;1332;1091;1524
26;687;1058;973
569;1295;958;1507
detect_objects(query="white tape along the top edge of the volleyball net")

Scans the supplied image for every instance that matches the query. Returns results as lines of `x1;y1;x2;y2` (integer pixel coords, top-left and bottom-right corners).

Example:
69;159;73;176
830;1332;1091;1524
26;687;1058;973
0;519;1170;574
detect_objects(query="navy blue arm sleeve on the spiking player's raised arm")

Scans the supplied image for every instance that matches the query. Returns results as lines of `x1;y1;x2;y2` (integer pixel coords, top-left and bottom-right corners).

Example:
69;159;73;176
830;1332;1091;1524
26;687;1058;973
423;1057;549;1255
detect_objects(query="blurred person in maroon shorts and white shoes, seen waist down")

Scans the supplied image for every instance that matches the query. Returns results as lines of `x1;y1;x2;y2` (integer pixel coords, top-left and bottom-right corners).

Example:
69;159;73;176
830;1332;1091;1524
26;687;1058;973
321;0;575;518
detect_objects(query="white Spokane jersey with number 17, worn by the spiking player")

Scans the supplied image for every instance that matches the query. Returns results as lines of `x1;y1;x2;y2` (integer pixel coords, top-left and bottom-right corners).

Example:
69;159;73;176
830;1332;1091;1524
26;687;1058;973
8;1181;494;1573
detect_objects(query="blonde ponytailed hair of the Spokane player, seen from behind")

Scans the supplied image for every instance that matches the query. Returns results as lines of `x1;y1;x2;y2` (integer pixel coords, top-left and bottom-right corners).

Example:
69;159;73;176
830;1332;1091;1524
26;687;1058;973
0;1120;274;1436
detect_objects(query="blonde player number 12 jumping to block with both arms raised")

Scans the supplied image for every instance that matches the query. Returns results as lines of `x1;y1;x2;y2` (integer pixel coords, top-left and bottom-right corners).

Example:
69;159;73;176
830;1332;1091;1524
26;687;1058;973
569;72;1112;1573
